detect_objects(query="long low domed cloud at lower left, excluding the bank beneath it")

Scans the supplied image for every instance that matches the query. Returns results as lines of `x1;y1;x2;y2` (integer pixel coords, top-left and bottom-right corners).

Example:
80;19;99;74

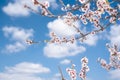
5;62;50;74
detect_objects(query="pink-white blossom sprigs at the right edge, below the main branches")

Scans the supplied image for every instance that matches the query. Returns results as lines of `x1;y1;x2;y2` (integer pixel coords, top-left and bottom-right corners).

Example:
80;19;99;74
98;44;120;70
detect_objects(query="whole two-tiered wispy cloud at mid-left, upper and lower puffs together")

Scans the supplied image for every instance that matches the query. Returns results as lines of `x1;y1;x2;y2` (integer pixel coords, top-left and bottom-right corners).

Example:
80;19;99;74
2;26;34;53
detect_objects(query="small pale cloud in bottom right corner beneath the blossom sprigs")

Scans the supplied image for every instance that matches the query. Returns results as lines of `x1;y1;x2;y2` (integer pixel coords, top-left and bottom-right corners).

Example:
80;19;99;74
109;69;120;80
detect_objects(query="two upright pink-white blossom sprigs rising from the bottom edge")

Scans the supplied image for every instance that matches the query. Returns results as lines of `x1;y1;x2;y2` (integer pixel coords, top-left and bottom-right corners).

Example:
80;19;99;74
66;57;89;80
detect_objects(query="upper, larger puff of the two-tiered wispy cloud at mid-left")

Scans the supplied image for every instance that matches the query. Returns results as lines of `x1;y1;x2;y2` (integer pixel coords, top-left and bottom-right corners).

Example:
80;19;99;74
3;26;33;41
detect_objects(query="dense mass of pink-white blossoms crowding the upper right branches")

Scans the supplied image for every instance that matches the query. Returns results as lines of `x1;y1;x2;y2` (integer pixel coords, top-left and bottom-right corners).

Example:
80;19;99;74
62;0;118;27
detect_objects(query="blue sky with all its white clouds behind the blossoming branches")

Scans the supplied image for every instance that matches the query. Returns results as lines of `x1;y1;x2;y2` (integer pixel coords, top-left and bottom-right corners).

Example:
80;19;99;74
0;0;120;80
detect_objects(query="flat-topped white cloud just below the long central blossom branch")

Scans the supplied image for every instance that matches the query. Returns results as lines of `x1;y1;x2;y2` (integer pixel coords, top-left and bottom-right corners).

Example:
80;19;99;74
44;43;86;58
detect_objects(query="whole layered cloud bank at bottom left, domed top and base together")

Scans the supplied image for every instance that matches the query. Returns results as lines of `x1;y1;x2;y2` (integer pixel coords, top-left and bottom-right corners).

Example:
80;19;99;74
0;62;50;80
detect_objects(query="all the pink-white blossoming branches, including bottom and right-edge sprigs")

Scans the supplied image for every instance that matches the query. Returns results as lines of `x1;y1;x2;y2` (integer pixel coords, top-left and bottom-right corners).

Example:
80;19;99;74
24;0;120;80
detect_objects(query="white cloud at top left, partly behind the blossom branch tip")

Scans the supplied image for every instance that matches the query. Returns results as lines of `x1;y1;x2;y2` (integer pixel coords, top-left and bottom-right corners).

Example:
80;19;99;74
2;0;57;17
